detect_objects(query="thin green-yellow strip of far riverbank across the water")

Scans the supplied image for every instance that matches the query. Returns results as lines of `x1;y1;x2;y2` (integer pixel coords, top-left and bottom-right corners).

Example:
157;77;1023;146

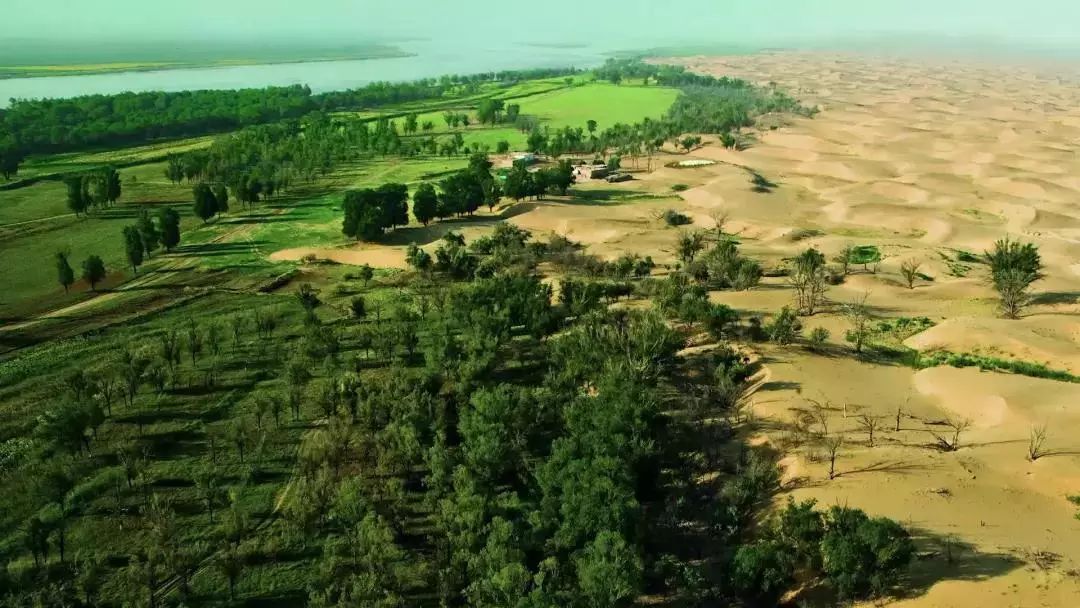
0;49;418;81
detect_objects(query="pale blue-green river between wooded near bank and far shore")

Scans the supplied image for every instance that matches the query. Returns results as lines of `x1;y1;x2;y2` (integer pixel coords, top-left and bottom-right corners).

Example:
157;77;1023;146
0;41;610;108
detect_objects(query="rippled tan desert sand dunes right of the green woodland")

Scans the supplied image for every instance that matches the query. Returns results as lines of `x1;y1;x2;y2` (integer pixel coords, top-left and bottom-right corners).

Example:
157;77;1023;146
665;53;1080;608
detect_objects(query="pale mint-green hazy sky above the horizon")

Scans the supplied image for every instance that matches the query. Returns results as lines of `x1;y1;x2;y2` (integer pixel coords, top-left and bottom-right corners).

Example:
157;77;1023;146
6;0;1080;51
